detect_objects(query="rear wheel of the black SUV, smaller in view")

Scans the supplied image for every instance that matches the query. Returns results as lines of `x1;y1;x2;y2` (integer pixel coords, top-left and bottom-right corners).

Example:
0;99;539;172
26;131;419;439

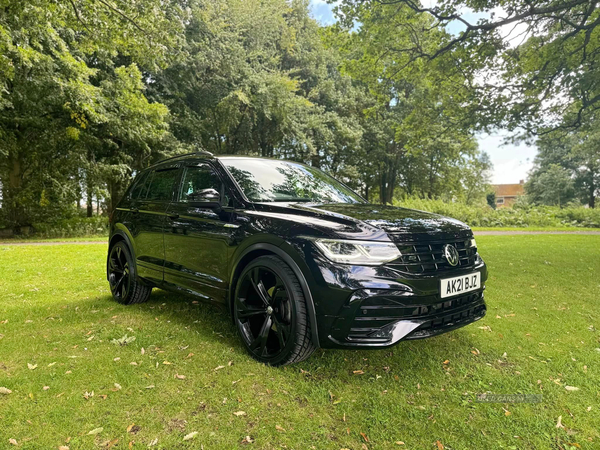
106;241;152;305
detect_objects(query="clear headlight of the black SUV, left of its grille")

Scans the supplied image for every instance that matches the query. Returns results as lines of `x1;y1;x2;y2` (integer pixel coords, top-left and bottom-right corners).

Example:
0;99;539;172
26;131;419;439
314;239;402;266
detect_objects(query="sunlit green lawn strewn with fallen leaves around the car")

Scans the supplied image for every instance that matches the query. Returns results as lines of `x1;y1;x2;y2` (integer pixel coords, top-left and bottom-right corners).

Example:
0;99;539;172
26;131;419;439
0;235;600;450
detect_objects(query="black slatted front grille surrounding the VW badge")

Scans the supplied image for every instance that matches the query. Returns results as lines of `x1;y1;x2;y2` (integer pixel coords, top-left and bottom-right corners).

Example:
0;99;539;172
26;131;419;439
388;239;477;273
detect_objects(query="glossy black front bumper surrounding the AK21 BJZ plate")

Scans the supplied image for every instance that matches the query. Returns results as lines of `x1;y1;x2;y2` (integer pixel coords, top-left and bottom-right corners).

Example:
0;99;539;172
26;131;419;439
299;241;487;349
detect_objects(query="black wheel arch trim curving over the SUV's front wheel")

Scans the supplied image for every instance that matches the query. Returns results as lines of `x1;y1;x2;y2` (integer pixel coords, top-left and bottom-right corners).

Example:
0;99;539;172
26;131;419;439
227;240;320;348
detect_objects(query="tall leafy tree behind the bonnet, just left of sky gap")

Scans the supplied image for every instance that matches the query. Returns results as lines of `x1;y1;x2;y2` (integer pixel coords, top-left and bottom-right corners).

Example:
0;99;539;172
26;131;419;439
327;0;483;203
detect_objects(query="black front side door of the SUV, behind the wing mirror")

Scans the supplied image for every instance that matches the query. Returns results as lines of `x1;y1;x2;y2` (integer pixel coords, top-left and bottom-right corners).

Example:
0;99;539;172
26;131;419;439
164;162;237;302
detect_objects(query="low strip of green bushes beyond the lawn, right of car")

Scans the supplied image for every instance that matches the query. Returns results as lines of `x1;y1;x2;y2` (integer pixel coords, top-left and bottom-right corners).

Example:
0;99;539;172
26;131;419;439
394;198;600;228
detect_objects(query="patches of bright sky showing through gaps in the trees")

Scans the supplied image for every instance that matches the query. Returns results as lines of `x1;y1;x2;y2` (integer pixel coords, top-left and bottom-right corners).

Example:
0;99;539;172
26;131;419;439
310;0;537;184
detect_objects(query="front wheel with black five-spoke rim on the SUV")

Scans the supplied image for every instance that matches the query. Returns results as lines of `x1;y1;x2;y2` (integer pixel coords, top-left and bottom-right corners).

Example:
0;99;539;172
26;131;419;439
232;256;316;366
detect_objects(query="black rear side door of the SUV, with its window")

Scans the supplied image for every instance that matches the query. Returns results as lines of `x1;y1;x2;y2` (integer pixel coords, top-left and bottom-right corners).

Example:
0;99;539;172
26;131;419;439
131;163;180;282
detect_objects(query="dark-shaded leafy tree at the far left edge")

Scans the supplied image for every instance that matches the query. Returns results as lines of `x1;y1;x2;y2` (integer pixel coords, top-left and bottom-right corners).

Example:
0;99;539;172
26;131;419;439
0;0;185;227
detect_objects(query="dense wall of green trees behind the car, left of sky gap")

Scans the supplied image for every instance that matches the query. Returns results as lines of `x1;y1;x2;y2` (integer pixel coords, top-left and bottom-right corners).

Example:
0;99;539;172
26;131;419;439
0;0;490;232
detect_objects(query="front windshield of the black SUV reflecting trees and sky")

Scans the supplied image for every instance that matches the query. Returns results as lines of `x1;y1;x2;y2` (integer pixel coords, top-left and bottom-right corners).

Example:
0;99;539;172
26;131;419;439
221;158;364;203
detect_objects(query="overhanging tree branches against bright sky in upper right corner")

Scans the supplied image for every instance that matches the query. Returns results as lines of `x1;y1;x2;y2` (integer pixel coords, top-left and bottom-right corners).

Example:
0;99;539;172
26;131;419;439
339;0;600;135
